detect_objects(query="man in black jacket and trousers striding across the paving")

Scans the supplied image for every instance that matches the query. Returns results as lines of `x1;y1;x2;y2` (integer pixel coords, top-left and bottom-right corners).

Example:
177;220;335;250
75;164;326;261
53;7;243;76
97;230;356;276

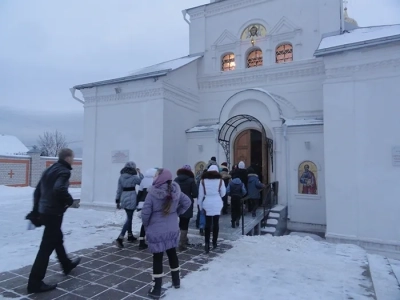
27;149;80;293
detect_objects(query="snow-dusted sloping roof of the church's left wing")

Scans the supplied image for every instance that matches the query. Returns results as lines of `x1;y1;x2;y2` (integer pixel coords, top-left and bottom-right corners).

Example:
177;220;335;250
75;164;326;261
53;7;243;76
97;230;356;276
73;56;201;90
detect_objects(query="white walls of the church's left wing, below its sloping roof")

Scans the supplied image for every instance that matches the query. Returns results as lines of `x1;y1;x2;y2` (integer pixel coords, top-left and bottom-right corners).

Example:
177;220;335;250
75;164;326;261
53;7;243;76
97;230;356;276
81;81;164;205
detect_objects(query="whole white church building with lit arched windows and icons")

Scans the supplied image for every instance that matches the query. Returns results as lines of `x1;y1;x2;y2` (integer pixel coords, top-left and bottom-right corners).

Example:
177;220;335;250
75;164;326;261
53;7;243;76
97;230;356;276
71;0;400;255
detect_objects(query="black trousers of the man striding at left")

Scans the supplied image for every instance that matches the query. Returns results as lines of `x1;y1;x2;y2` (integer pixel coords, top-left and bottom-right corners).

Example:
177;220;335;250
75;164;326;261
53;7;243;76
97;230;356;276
28;215;71;287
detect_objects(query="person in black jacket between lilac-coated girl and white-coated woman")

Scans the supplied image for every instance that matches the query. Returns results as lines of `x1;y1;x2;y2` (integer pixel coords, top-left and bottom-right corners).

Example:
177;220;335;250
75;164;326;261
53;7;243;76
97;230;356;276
175;165;198;251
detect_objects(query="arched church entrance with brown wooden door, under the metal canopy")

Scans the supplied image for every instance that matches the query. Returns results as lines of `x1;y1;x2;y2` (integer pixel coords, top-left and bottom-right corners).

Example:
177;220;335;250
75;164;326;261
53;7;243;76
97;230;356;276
233;129;269;182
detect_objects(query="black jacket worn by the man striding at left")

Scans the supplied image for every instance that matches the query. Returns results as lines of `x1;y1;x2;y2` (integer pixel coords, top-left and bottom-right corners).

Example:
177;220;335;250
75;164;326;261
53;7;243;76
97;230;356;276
33;160;74;216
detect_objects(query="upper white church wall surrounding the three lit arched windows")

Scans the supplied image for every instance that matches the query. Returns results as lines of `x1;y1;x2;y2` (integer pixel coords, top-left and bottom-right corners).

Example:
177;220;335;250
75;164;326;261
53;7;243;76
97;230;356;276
188;0;340;68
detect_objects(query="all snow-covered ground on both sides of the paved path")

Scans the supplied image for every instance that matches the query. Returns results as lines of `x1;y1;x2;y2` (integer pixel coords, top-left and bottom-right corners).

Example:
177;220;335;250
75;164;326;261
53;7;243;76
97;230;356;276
0;186;400;300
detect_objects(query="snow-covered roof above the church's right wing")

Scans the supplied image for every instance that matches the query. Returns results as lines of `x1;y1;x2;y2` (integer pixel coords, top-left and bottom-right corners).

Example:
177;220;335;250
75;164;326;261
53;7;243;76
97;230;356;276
316;24;400;54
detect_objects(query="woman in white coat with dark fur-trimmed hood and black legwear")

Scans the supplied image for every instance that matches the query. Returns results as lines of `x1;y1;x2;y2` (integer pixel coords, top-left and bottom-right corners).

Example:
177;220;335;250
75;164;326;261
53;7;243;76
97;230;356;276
197;165;226;253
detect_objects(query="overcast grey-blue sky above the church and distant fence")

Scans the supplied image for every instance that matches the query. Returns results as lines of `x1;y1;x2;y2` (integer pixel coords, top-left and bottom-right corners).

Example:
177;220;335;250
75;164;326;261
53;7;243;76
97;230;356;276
0;0;400;155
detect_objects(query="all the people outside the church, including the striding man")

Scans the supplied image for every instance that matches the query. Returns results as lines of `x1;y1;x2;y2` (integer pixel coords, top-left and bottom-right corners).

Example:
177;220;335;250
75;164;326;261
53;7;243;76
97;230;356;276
26;149;263;299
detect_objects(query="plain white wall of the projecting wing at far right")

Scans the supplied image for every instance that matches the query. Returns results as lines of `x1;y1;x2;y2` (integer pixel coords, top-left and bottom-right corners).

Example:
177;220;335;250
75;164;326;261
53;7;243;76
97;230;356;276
324;44;400;251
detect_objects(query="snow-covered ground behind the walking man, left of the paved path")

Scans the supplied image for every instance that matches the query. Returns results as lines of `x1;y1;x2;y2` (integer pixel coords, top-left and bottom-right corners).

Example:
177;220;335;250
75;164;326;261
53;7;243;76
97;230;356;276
0;186;141;272
